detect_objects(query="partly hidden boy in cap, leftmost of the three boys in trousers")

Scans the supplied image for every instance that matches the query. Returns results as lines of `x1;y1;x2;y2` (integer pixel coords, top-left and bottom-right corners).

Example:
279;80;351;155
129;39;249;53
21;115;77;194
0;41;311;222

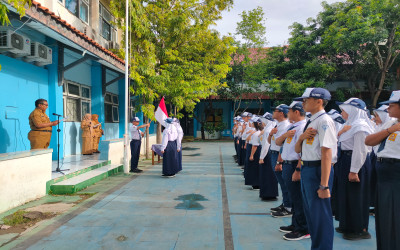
268;104;292;216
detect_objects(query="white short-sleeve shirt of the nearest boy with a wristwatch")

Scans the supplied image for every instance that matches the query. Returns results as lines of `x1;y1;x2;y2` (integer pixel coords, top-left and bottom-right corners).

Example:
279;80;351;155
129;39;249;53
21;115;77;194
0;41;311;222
301;110;337;163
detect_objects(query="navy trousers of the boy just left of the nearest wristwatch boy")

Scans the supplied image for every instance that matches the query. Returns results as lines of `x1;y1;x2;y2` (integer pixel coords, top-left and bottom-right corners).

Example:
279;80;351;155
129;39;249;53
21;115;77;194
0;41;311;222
282;163;308;233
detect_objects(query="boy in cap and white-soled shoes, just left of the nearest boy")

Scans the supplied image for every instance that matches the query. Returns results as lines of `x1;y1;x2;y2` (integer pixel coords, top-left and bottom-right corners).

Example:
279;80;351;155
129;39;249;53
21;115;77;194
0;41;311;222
272;101;310;240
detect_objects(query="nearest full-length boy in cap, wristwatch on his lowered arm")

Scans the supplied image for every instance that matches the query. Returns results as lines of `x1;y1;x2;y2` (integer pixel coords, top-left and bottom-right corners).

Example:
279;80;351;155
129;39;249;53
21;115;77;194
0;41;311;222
295;88;337;250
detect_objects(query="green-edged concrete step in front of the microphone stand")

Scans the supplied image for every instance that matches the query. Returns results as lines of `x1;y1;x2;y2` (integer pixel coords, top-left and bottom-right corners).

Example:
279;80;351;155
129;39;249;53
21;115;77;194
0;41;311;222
50;164;124;194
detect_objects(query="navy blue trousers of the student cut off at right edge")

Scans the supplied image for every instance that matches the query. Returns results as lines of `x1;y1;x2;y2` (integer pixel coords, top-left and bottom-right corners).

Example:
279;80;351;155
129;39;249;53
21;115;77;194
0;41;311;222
375;162;400;250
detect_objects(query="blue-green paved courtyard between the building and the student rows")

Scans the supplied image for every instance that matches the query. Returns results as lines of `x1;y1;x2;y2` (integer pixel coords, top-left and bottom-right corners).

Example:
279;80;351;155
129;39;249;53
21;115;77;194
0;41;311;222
11;142;376;250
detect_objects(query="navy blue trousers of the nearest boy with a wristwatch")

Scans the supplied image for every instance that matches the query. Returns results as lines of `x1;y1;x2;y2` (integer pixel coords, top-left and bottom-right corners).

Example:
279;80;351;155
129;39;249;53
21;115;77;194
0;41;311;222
301;166;333;250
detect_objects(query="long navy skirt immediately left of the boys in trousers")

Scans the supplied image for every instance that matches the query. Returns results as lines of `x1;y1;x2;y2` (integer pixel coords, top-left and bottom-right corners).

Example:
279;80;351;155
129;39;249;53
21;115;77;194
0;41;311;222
259;151;278;199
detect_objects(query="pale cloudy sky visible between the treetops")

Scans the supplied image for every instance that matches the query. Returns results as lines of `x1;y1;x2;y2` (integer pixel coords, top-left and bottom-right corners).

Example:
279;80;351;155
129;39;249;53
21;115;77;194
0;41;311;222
215;0;344;47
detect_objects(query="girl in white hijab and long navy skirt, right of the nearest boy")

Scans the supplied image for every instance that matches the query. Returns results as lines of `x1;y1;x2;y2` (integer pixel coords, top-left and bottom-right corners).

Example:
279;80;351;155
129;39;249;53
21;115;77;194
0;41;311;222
336;98;374;240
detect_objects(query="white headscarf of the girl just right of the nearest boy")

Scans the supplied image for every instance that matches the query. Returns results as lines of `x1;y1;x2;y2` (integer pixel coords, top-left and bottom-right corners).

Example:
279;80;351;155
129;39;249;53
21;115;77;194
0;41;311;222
339;104;374;142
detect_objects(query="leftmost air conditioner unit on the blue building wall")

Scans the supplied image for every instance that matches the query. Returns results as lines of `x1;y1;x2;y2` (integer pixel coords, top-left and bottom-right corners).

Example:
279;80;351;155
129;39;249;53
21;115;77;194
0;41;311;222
0;28;31;57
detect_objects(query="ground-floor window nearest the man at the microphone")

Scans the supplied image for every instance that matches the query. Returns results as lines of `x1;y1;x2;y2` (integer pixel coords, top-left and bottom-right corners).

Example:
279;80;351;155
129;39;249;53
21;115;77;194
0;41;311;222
63;81;91;122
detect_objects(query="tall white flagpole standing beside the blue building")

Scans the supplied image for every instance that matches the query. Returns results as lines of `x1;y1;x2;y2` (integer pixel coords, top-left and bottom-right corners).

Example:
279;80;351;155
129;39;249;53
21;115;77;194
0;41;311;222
124;0;129;173
